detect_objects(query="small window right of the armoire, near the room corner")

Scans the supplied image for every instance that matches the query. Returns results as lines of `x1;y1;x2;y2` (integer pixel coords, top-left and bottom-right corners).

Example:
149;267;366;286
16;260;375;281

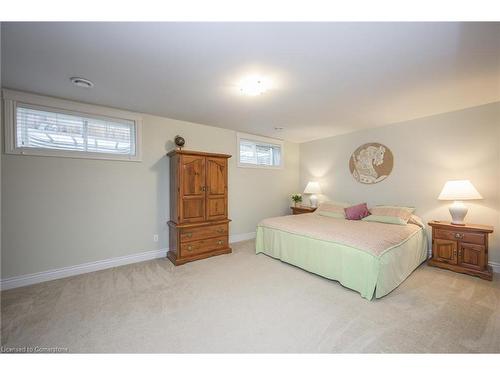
237;133;284;169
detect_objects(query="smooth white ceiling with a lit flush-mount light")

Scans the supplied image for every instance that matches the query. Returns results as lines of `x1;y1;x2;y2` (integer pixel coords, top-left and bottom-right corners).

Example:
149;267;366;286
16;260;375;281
2;23;500;142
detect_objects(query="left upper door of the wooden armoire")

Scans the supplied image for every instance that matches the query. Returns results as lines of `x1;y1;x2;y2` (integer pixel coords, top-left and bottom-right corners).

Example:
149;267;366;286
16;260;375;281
179;155;206;223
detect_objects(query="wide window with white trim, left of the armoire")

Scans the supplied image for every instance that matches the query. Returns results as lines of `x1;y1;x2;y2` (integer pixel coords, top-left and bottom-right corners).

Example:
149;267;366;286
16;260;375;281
4;90;140;161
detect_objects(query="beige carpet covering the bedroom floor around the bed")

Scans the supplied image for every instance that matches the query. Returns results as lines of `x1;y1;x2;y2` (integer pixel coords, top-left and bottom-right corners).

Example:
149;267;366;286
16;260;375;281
2;241;500;353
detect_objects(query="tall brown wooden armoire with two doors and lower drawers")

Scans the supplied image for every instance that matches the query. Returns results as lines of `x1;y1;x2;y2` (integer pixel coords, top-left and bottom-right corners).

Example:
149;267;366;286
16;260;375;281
167;150;231;265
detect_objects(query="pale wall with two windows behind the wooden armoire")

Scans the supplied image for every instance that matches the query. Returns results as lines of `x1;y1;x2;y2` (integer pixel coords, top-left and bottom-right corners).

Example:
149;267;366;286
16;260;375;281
2;108;299;278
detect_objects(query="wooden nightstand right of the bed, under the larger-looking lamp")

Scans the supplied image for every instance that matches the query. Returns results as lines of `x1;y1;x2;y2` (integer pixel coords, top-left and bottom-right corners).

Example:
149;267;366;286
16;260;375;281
427;221;493;280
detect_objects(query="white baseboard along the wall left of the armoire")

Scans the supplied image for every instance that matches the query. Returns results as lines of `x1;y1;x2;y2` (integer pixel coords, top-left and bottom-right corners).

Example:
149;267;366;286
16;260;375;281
0;249;167;290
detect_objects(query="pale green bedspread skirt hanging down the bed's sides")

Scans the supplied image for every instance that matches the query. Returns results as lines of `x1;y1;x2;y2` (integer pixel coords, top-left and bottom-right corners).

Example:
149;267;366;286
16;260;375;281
255;224;427;300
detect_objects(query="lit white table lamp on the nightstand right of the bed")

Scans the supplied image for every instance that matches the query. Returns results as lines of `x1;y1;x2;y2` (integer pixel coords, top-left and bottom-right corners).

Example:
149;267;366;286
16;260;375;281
438;180;483;225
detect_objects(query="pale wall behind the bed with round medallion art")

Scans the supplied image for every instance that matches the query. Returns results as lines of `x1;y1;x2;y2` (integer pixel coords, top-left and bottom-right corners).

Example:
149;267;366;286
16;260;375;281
300;103;500;262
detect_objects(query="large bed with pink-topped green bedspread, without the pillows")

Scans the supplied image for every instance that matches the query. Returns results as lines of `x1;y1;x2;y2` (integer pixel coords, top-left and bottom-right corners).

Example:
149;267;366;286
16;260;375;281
255;213;427;300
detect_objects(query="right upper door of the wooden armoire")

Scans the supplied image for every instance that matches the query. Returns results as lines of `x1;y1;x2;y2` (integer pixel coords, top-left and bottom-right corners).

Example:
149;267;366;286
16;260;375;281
206;157;227;220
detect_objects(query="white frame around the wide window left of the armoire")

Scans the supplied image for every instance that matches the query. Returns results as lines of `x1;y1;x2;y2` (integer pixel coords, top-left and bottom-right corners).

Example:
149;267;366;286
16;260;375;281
2;89;142;162
